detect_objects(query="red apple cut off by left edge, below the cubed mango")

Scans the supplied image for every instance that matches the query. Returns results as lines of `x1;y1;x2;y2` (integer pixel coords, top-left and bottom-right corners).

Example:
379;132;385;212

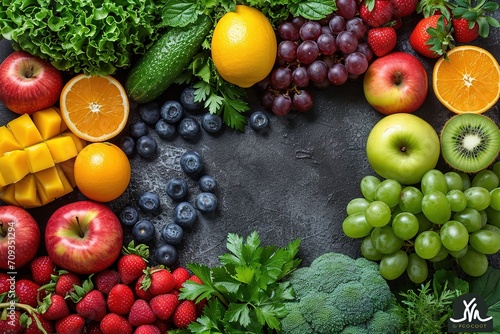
0;205;40;271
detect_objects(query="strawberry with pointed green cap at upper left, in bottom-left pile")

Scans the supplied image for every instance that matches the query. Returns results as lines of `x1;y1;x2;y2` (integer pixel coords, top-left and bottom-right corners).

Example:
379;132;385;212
70;275;107;321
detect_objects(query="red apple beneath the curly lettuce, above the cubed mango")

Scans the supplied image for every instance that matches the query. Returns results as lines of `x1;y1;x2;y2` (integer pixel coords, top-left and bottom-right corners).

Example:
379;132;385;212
0;51;63;114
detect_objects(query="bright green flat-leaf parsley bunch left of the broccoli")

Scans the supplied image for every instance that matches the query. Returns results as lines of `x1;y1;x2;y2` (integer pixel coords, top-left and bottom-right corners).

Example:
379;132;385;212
179;232;300;333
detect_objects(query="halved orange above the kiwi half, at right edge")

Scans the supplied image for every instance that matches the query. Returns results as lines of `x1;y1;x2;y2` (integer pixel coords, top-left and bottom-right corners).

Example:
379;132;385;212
432;45;500;114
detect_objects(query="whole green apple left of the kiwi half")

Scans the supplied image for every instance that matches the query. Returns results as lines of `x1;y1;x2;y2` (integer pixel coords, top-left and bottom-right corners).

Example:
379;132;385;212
366;113;440;185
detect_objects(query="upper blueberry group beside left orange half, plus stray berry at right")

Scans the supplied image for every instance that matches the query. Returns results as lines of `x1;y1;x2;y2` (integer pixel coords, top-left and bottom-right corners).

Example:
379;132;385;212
119;86;269;159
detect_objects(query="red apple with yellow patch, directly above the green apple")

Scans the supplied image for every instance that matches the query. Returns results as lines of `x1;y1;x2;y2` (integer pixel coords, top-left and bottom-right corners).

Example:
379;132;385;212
363;51;429;115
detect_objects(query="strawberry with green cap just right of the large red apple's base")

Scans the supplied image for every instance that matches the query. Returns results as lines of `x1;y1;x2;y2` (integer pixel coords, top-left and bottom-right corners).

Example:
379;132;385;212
118;241;149;284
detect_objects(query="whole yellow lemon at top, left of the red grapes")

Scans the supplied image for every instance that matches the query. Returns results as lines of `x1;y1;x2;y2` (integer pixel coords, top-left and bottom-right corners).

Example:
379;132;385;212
211;5;277;88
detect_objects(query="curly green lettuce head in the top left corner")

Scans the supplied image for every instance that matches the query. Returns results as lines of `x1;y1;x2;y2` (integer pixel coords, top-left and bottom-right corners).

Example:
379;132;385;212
0;0;167;75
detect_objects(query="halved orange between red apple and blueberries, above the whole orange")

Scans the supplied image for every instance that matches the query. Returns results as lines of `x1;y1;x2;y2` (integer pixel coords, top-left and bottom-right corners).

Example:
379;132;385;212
59;74;130;142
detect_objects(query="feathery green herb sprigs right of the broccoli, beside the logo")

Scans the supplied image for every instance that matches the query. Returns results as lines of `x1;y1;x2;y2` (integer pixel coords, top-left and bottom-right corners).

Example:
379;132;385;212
399;269;469;334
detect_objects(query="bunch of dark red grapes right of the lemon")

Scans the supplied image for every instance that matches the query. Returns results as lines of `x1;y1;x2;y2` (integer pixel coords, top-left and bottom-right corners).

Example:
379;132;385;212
259;0;373;116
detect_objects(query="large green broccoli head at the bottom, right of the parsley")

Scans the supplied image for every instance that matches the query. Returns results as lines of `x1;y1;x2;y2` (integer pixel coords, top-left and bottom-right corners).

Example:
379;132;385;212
282;252;401;334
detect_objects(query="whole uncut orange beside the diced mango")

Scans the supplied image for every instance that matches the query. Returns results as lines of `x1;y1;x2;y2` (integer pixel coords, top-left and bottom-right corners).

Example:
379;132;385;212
74;142;130;202
